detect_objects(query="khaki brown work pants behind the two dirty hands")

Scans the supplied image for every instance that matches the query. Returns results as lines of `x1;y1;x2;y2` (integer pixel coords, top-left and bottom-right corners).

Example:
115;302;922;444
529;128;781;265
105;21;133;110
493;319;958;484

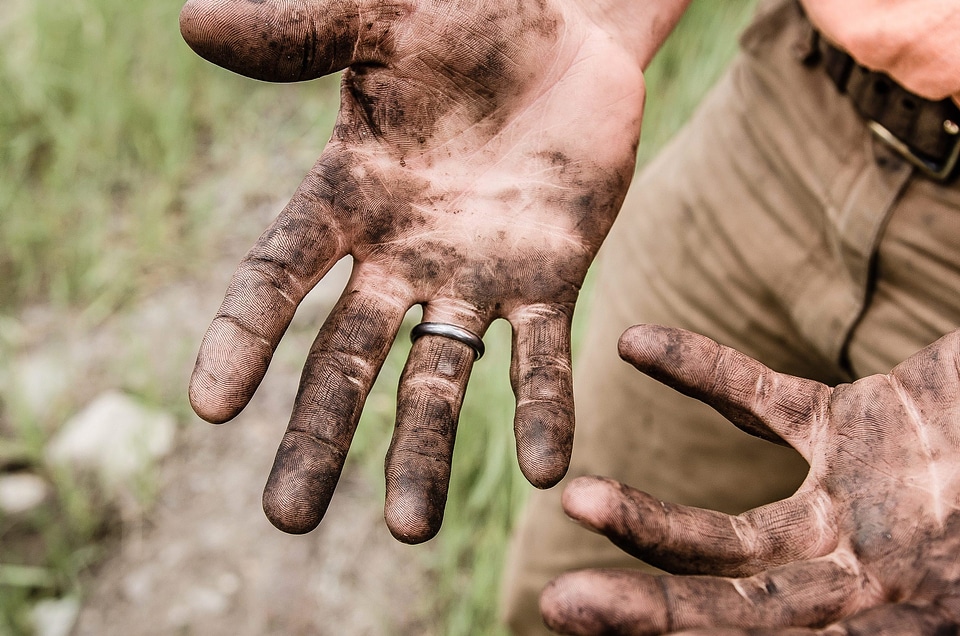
502;1;960;635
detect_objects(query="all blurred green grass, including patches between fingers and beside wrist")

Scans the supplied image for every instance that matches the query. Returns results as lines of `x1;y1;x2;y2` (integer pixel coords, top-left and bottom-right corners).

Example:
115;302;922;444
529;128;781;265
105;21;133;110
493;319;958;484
0;0;753;636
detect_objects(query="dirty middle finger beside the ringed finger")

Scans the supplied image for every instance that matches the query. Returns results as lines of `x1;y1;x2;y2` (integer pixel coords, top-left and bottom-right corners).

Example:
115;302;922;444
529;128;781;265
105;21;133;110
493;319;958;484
263;281;409;534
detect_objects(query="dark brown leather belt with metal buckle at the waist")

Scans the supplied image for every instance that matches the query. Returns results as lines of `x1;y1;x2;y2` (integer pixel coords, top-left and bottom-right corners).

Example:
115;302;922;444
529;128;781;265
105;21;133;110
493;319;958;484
803;23;960;182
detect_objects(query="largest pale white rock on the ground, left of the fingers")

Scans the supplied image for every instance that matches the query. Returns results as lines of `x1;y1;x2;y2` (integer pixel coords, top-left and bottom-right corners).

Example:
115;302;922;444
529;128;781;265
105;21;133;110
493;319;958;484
46;391;176;491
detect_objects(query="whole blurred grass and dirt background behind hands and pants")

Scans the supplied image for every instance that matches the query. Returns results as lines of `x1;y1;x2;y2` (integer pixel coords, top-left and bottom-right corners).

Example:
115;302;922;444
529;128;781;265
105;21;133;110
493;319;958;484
0;0;754;636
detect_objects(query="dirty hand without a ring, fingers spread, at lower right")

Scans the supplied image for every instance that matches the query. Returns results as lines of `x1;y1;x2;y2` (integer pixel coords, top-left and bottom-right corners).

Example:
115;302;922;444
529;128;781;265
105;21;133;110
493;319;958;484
541;326;960;636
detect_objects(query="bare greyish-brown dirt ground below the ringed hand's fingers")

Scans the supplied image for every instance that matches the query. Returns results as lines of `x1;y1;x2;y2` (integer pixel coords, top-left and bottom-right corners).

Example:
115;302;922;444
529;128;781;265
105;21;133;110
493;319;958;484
66;260;431;636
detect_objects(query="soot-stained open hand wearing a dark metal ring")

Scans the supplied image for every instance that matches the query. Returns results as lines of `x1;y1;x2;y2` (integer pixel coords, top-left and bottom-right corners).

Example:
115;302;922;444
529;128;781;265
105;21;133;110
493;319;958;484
181;0;672;543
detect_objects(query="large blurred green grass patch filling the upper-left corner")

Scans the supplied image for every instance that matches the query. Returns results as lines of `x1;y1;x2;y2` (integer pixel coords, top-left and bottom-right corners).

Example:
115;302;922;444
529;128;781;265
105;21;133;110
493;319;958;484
0;0;338;313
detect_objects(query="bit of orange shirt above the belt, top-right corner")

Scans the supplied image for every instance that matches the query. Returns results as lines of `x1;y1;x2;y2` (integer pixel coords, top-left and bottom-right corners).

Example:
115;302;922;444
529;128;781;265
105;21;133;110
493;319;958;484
801;0;960;104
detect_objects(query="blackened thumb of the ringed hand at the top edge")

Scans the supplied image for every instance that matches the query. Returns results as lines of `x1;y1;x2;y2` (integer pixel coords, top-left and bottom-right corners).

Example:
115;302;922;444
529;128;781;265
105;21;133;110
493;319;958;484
180;0;403;82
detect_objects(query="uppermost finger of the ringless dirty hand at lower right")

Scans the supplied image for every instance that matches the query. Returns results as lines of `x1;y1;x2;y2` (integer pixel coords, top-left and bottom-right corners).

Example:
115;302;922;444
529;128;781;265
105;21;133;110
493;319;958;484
620;325;830;461
